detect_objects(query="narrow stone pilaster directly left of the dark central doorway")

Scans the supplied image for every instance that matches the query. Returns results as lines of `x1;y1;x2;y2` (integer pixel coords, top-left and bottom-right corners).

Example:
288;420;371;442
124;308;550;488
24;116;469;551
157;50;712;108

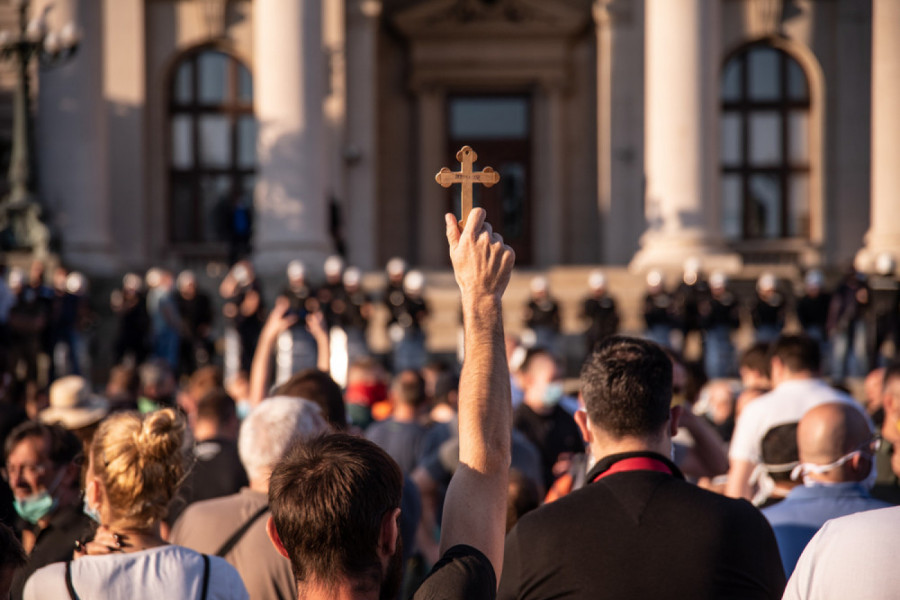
415;87;444;267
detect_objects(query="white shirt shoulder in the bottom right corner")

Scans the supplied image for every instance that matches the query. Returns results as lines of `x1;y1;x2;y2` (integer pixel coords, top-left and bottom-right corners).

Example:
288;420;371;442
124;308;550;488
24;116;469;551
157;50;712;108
784;506;900;600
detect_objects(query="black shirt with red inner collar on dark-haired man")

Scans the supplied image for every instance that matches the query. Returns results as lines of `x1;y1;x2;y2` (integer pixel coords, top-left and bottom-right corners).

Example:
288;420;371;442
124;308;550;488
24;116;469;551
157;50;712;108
498;452;785;600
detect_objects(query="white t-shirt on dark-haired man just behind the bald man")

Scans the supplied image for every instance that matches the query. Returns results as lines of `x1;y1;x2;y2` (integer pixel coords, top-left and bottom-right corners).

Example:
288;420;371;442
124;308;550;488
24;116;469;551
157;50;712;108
728;379;865;464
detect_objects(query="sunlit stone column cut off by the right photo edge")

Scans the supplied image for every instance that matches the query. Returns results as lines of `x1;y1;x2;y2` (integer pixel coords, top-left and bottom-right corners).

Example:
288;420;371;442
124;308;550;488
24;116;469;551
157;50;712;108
856;0;900;271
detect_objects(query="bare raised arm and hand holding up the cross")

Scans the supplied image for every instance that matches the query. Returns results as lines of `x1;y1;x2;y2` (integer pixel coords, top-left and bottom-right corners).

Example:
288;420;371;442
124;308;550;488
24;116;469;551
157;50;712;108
441;208;515;581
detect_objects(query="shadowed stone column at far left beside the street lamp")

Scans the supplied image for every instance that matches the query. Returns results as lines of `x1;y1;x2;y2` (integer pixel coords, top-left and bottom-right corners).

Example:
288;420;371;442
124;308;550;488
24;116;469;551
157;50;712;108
33;0;118;275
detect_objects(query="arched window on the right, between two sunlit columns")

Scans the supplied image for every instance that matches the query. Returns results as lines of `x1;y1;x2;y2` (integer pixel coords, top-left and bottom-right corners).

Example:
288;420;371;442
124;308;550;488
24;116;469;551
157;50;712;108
720;44;810;240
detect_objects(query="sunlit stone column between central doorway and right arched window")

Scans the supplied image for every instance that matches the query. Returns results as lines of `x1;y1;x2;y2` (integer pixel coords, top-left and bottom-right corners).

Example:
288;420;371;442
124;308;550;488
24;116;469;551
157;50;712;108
630;0;740;271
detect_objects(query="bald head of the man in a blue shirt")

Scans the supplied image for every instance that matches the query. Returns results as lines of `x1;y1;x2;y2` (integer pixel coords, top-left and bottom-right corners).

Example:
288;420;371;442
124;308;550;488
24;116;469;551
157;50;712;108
797;403;872;471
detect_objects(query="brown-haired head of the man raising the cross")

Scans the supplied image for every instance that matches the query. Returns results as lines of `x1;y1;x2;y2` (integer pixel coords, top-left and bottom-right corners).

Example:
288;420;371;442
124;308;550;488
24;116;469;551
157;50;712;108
268;433;403;598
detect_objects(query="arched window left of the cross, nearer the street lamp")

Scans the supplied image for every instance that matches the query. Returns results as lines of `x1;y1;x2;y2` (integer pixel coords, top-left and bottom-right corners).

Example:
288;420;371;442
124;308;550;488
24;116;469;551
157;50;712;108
169;48;256;243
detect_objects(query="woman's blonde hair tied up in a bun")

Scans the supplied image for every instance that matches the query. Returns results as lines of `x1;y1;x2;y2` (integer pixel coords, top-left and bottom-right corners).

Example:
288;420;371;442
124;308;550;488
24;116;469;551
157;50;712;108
90;408;186;528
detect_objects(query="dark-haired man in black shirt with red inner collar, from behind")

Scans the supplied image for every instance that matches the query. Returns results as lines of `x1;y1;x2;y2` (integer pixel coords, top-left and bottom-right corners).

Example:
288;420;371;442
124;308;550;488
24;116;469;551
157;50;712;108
498;336;785;600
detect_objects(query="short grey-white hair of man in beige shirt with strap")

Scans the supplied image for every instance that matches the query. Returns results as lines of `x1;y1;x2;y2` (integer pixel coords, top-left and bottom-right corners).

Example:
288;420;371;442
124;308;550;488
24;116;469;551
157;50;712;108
238;396;329;481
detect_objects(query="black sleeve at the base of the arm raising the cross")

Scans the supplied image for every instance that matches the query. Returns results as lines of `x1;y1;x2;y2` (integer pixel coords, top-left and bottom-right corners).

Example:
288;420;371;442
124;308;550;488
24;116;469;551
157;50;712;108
413;545;497;600
